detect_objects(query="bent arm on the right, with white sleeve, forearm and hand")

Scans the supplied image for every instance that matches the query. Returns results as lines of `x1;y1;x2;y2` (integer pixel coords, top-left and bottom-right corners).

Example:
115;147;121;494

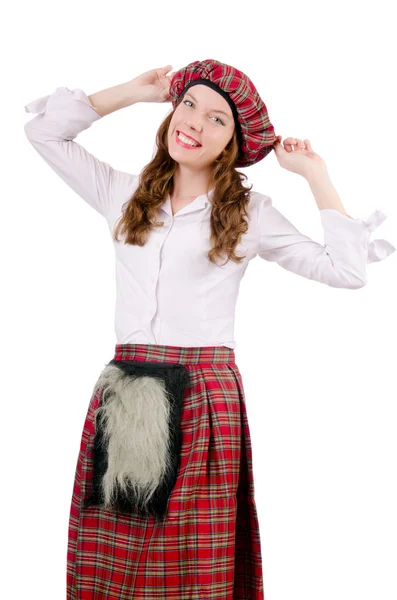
257;136;396;288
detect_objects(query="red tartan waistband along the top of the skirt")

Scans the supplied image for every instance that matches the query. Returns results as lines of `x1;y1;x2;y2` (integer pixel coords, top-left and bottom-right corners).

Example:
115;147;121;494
114;343;235;366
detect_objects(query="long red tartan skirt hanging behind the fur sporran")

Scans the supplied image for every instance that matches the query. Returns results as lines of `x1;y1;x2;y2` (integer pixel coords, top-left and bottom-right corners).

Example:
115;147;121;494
66;343;264;600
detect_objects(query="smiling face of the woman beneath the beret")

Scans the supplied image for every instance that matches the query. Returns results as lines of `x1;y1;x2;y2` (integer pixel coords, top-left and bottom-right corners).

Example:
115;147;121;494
167;85;235;170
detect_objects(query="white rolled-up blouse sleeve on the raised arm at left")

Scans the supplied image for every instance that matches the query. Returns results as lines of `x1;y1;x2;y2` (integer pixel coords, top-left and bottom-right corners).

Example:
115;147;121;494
25;87;134;217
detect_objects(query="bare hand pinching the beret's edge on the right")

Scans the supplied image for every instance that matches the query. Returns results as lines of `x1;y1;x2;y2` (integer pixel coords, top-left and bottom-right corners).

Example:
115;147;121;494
274;135;325;178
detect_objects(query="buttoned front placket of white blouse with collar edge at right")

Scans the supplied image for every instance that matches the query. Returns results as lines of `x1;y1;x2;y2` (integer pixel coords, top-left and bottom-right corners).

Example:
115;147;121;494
144;190;212;344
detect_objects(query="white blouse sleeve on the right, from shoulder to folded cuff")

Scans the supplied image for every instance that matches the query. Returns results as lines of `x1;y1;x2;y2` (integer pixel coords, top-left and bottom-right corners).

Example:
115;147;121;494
257;194;396;288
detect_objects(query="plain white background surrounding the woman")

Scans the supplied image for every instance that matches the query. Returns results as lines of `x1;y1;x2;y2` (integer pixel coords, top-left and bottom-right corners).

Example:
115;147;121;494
1;0;397;600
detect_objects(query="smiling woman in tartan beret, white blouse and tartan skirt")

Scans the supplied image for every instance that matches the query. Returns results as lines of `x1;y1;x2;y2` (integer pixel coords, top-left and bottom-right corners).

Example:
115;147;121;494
25;60;395;600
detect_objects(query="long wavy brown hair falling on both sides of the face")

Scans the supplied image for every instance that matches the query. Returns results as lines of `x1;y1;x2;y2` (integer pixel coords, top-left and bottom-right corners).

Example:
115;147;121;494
113;98;252;263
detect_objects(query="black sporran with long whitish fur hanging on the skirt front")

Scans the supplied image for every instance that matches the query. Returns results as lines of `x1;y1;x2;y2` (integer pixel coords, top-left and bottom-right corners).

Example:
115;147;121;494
84;359;189;518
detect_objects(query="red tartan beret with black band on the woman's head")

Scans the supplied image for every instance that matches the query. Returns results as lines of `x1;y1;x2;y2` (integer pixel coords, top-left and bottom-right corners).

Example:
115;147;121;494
169;59;276;167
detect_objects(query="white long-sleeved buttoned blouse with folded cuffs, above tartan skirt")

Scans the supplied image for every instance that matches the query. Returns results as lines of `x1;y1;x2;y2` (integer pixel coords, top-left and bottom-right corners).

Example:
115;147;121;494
25;87;396;348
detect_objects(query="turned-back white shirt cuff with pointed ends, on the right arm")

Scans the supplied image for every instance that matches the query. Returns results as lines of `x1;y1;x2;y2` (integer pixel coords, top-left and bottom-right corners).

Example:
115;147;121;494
320;208;396;263
